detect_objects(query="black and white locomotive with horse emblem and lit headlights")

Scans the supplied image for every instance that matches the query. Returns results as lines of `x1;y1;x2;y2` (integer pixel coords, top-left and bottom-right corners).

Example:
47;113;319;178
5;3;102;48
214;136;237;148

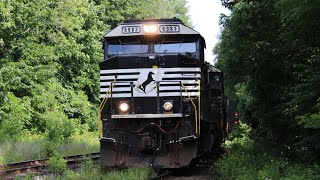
98;18;228;168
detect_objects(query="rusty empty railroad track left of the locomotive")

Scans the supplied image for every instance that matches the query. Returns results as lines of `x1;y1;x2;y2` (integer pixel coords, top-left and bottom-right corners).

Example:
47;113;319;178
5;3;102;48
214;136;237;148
0;153;100;179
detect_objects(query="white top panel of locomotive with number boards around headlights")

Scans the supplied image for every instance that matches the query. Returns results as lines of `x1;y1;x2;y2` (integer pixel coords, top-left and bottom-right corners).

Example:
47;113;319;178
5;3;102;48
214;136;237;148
105;18;203;38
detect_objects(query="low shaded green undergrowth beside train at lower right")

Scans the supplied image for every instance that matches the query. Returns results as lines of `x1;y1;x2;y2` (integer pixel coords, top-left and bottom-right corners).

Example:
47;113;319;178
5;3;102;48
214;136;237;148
210;124;320;180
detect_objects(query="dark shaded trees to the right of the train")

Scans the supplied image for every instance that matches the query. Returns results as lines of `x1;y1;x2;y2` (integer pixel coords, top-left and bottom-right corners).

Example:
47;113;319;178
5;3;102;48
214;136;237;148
215;0;320;162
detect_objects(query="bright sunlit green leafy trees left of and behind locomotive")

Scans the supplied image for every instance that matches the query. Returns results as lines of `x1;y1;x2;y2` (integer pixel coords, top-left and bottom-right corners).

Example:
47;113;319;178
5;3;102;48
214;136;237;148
0;0;190;141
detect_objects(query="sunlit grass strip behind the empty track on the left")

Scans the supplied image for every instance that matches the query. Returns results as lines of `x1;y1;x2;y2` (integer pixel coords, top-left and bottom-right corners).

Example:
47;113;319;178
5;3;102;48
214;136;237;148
0;132;100;164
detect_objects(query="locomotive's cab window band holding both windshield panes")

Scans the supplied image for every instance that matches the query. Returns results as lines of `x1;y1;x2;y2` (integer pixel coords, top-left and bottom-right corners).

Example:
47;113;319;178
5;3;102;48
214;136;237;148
104;35;201;60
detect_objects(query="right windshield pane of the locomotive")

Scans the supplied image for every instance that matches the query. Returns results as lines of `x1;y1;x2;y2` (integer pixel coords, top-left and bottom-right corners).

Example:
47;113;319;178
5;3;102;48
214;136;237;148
154;42;197;53
